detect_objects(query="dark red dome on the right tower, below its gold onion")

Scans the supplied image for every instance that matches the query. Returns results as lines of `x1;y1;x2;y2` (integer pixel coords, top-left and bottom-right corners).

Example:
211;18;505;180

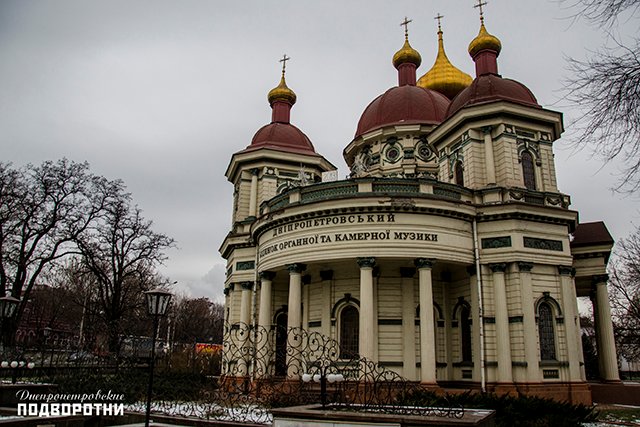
447;74;542;117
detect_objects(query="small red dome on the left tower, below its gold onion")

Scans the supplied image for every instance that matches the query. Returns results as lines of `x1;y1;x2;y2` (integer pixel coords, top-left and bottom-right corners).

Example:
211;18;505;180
247;123;316;153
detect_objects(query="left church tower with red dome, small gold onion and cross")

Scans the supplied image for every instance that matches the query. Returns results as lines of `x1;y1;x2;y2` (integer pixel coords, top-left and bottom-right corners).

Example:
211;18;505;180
220;55;336;324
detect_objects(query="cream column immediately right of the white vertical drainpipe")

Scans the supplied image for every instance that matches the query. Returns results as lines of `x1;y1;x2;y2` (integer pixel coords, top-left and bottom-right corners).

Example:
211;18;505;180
489;263;513;383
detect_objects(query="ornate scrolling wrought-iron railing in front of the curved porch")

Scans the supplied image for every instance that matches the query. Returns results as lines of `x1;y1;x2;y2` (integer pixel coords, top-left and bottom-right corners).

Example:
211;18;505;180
212;324;464;421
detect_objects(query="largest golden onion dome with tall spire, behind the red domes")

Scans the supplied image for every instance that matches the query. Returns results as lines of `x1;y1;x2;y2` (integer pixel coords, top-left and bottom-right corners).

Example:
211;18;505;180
417;30;473;99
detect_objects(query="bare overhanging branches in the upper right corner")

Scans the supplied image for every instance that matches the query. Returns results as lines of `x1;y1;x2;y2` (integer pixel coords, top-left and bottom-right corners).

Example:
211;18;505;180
566;0;640;193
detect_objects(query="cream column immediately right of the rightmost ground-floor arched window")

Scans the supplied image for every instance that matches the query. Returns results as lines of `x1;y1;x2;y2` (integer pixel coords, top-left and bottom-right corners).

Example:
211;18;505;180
558;265;584;381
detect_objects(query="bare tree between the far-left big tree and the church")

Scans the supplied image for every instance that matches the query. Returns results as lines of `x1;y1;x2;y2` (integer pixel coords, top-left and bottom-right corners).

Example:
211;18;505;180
77;192;174;354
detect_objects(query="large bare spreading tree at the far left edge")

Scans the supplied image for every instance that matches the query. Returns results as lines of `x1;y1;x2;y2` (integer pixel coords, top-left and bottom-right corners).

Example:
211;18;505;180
0;159;122;343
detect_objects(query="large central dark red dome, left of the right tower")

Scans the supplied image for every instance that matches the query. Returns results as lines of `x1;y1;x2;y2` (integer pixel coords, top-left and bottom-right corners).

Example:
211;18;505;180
356;85;449;138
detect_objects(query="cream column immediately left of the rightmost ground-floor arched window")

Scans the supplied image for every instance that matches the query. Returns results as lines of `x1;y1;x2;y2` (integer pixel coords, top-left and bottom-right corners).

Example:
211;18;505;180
518;262;542;382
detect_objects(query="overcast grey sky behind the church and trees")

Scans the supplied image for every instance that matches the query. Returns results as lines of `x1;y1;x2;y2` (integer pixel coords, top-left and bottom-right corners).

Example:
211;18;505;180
0;0;640;299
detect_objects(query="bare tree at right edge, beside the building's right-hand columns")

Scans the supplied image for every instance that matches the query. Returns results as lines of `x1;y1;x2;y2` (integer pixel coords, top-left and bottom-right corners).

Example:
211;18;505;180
609;228;640;360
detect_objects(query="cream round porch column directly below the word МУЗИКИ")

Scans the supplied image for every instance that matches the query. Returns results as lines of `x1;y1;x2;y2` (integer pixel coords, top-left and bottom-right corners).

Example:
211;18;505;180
415;258;436;384
